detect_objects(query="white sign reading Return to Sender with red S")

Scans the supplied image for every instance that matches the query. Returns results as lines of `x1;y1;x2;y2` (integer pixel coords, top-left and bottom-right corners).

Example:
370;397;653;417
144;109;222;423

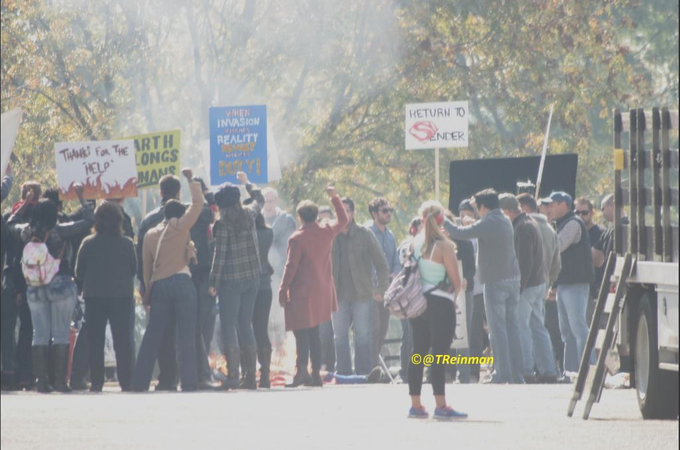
405;102;469;150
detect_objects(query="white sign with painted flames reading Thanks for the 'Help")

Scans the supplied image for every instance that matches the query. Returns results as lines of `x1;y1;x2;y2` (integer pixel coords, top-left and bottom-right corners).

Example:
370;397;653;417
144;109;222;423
54;139;137;200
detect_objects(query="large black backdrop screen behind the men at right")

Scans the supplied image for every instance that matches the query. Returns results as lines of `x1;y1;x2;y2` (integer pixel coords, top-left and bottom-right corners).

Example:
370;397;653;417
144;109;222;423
449;154;578;214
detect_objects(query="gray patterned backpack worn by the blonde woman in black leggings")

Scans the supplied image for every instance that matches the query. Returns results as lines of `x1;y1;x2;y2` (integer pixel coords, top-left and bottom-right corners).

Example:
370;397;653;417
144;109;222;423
385;250;427;319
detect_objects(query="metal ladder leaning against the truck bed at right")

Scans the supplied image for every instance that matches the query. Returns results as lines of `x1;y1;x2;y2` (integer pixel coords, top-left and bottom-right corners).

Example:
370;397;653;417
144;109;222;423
567;252;634;420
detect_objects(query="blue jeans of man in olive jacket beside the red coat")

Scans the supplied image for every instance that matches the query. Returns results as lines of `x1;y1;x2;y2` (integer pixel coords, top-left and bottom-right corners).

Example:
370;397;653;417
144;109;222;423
333;299;374;375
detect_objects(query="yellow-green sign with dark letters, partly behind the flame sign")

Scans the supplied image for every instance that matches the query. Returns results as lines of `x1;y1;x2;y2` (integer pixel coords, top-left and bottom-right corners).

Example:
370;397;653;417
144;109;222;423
123;130;181;189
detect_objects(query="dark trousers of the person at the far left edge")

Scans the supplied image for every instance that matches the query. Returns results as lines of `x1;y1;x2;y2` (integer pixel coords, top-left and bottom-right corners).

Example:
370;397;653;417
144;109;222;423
0;288;33;384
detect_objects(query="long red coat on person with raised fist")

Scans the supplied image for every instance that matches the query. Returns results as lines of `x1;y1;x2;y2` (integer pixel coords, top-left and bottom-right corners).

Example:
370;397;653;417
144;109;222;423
279;196;348;331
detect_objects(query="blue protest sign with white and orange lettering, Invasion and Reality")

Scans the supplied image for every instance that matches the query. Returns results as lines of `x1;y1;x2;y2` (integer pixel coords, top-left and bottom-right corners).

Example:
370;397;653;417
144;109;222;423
209;105;269;186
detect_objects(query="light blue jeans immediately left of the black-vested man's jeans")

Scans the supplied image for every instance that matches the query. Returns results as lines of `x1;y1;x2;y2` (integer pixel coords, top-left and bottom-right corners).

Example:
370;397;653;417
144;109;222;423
519;283;557;376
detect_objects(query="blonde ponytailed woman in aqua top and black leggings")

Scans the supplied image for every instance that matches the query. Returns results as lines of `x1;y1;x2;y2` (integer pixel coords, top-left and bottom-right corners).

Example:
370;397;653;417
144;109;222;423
408;201;467;420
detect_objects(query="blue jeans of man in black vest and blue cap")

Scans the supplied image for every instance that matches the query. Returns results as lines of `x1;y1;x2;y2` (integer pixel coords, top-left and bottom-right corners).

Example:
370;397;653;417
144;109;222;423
557;284;590;372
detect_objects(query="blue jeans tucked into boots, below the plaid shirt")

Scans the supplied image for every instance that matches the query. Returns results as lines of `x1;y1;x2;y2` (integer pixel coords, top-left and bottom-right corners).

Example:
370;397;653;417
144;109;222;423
219;278;260;350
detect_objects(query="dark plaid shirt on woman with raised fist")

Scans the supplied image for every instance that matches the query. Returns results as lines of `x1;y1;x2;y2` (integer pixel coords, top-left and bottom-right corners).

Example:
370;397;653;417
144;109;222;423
210;208;262;288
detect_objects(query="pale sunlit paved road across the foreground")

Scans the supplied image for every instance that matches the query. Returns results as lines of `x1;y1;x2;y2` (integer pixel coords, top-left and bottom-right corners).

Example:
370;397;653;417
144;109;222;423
1;385;678;450
